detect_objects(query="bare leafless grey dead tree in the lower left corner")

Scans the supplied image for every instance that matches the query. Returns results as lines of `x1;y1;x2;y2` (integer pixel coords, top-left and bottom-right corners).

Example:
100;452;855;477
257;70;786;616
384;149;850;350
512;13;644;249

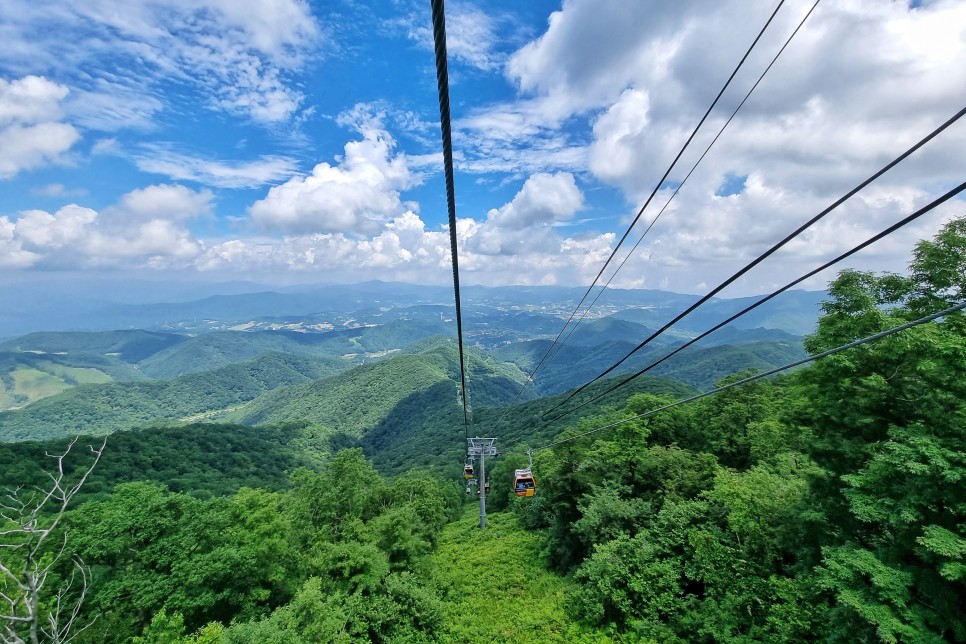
0;438;107;644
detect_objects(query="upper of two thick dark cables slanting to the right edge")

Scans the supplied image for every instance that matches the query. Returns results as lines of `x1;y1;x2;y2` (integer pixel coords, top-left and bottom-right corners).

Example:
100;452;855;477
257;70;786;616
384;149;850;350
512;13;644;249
541;107;966;418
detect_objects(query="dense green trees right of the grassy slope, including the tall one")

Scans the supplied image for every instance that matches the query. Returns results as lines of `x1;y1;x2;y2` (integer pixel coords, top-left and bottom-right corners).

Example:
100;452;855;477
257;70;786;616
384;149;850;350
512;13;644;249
514;215;966;642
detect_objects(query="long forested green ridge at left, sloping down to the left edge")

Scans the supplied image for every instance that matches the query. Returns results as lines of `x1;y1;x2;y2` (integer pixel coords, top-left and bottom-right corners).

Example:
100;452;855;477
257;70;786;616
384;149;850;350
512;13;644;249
0;353;348;441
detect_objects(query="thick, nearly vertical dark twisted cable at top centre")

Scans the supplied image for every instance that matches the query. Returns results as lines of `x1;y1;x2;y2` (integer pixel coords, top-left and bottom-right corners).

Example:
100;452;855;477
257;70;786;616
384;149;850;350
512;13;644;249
430;0;469;439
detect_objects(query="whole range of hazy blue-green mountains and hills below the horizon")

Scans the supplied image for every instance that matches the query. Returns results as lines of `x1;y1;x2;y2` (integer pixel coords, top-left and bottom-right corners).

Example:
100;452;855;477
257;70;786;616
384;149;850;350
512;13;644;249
0;283;824;478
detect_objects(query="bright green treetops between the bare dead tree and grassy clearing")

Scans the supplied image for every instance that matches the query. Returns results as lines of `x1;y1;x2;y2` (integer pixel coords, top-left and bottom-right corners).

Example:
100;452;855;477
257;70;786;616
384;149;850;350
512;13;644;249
46;449;460;642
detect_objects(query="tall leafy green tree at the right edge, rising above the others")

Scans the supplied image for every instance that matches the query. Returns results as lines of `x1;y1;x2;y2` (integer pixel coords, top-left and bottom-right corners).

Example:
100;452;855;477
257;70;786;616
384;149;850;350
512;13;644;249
799;218;966;641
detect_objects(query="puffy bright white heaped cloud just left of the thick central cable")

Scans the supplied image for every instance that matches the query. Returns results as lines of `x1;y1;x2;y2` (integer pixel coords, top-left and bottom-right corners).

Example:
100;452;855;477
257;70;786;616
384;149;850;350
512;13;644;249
250;116;416;235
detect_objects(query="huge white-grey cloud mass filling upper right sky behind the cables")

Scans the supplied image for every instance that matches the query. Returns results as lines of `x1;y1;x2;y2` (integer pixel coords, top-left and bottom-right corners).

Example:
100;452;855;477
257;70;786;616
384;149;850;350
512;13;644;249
484;0;966;291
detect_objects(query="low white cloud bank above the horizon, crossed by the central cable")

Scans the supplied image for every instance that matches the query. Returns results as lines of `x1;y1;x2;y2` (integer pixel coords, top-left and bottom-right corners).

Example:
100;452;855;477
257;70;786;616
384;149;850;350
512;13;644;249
196;173;614;284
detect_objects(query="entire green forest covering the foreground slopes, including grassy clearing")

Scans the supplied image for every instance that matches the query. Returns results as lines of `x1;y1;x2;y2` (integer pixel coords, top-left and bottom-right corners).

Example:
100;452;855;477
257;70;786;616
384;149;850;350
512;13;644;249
0;219;966;644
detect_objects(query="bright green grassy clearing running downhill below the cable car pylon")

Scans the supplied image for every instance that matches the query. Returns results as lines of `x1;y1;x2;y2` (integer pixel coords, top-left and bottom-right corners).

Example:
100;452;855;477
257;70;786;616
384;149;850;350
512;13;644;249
433;506;614;643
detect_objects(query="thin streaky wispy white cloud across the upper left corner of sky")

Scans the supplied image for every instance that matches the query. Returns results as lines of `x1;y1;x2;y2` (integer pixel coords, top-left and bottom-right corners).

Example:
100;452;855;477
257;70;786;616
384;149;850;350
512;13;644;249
0;0;323;131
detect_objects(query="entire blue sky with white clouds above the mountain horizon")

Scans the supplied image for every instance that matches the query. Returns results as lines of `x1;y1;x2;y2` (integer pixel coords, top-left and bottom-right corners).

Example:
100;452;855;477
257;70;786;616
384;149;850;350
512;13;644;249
0;0;966;296
